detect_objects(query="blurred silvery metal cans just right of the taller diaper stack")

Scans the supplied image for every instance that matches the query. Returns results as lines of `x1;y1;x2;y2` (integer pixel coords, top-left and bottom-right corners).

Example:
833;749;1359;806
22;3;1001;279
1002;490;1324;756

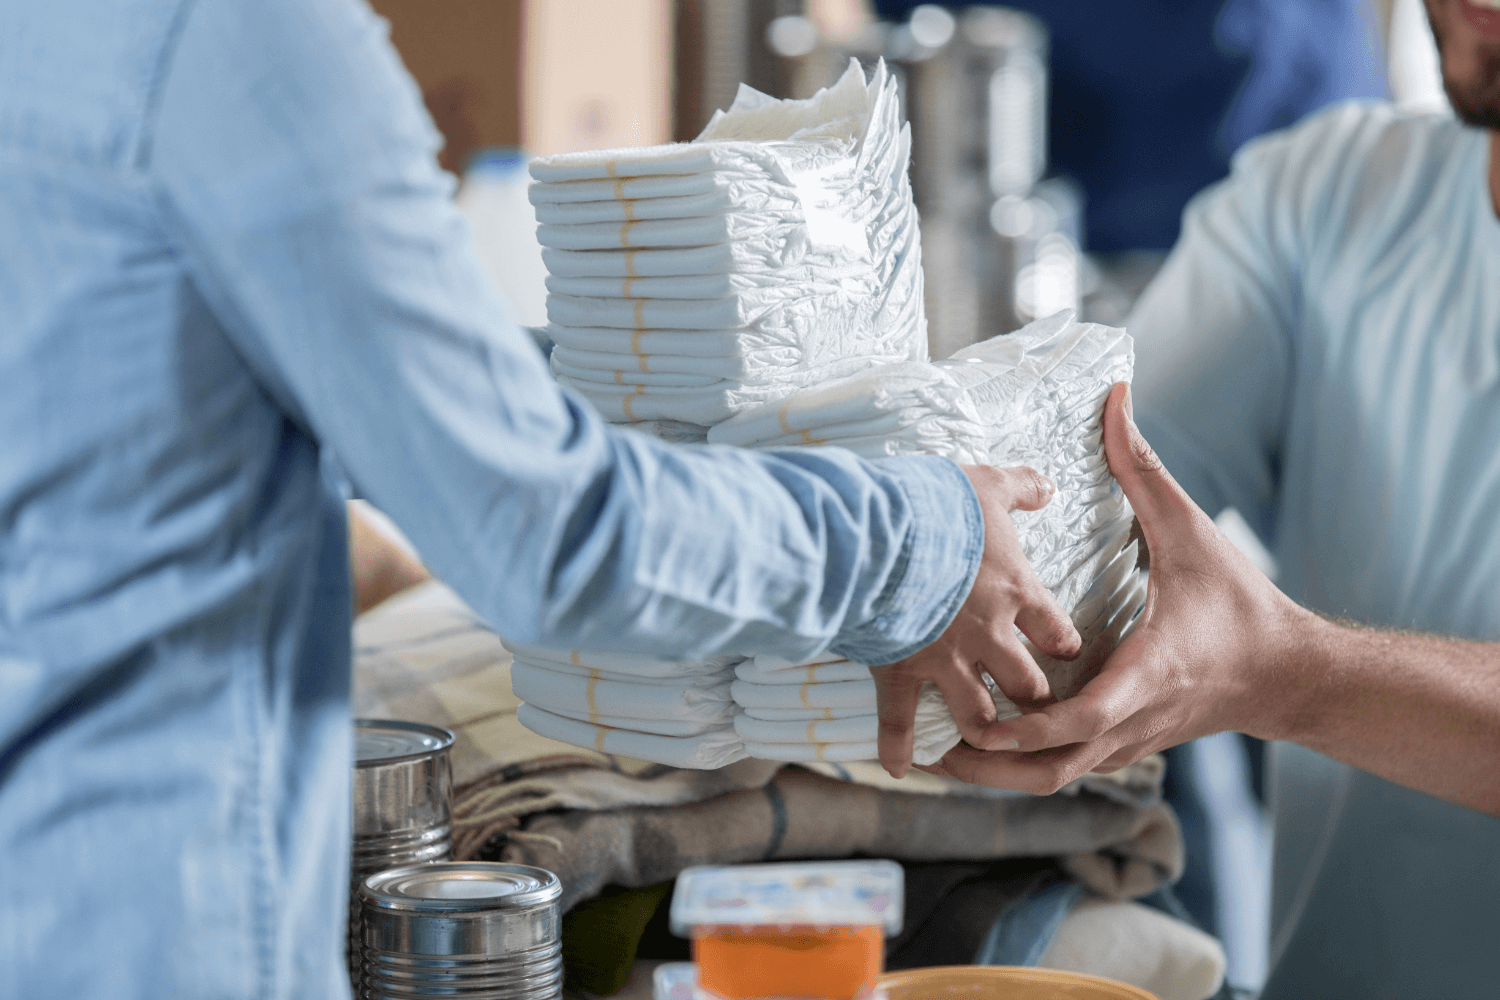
890;6;1083;358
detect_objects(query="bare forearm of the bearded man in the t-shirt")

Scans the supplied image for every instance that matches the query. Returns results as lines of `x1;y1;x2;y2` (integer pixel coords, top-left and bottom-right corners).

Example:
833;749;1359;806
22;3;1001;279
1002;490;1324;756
1256;616;1500;816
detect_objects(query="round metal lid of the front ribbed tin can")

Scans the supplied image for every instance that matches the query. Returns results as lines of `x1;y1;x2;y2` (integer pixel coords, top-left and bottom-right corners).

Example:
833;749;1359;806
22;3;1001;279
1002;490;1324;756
360;861;563;913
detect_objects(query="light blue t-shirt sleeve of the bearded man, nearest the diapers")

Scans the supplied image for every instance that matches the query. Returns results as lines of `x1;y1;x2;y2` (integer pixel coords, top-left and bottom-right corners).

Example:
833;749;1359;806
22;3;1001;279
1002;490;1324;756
1127;105;1361;543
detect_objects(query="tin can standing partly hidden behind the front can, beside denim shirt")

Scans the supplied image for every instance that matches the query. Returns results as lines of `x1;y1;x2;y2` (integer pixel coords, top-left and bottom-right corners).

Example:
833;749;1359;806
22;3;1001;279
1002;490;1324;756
348;718;453;990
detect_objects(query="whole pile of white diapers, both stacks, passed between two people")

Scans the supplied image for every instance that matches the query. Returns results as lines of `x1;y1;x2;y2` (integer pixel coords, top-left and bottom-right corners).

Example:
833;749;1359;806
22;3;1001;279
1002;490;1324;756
507;63;1146;768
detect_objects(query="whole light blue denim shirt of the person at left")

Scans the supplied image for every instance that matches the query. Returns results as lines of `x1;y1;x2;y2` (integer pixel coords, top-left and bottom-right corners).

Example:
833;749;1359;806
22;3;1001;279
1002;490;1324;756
0;0;983;1000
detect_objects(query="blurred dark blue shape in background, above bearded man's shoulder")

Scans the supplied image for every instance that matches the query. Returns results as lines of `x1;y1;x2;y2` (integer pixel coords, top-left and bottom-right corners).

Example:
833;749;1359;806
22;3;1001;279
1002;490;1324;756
875;0;1386;253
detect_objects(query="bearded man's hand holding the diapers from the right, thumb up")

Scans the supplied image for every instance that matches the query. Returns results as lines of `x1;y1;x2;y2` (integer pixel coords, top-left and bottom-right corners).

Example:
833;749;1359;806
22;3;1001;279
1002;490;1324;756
924;382;1317;795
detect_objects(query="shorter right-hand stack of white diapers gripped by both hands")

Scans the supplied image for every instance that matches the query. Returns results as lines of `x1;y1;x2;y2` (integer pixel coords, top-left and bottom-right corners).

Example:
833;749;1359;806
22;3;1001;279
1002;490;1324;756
708;310;1146;763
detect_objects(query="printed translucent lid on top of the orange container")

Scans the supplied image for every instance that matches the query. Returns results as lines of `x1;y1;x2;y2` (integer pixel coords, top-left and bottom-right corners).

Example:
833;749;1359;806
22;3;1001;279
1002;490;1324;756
672;861;903;937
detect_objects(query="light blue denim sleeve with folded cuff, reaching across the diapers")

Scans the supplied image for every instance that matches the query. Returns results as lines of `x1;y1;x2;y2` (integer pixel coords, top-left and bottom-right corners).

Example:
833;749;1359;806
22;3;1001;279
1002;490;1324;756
143;0;984;663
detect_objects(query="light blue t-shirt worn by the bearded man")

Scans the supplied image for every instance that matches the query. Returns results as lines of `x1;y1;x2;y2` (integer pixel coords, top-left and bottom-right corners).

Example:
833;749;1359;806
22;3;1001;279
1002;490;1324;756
1128;105;1500;1000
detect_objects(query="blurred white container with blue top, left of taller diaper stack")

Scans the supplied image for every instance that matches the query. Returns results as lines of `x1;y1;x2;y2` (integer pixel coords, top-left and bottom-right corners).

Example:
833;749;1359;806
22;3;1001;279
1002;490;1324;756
453;148;548;327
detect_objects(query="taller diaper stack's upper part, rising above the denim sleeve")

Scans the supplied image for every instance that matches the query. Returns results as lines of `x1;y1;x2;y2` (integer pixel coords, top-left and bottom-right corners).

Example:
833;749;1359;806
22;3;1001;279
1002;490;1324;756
530;60;927;427
